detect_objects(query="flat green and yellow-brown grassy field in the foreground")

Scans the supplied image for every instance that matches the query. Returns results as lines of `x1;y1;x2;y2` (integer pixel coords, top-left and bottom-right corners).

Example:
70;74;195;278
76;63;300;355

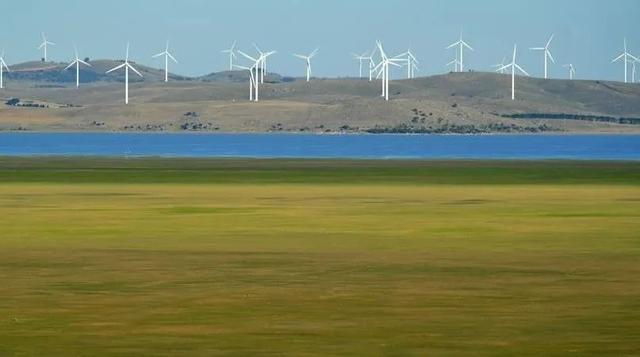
0;158;640;356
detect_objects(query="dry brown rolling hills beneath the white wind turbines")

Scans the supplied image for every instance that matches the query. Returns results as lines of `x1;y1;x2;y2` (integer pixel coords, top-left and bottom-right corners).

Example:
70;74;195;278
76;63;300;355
0;60;640;133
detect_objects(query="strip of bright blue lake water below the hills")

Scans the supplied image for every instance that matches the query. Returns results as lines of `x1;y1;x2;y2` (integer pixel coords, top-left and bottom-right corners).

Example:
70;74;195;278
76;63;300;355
0;133;640;160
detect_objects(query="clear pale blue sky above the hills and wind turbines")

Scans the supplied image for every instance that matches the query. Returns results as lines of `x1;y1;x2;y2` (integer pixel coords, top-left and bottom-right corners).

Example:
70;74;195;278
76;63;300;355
0;0;640;80
